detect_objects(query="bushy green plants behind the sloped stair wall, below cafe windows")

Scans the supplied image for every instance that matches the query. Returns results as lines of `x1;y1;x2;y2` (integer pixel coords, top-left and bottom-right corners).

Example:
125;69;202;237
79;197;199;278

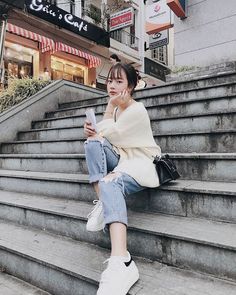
0;77;51;113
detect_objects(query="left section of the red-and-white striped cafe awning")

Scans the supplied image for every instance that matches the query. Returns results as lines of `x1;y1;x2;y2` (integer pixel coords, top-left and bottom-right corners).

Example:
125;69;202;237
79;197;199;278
7;23;55;52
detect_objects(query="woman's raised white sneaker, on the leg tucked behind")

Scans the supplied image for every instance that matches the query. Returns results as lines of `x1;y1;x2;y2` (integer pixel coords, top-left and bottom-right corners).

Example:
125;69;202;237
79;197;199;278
86;200;105;231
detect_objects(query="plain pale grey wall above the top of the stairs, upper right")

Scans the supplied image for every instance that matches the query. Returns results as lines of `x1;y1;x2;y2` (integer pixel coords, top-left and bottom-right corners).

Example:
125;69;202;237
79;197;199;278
175;0;236;66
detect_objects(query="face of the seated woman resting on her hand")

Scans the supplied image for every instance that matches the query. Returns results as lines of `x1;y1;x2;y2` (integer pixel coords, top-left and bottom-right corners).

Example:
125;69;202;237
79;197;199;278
107;69;131;97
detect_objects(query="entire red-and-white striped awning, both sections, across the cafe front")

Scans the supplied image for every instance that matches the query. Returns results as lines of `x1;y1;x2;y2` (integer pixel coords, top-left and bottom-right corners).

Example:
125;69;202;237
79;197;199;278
7;23;102;68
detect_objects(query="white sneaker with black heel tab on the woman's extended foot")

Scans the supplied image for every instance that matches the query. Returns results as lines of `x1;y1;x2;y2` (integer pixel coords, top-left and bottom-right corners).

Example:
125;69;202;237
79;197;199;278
97;254;139;295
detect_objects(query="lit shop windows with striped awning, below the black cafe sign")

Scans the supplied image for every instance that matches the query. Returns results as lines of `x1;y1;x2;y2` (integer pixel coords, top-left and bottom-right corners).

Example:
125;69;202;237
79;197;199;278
4;23;101;86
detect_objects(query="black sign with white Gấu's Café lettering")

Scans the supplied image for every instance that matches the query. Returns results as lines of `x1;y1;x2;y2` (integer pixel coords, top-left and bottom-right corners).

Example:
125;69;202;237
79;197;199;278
25;0;110;47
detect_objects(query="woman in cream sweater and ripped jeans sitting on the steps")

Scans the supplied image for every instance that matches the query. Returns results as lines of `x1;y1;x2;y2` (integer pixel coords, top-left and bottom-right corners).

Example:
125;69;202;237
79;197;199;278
84;63;161;295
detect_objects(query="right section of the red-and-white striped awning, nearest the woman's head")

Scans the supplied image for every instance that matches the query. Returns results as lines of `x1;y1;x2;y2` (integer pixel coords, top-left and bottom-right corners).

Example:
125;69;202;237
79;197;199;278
55;42;102;68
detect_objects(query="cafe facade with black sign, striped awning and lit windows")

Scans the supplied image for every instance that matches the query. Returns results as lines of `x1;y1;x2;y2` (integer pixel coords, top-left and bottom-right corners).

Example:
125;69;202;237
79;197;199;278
4;0;110;86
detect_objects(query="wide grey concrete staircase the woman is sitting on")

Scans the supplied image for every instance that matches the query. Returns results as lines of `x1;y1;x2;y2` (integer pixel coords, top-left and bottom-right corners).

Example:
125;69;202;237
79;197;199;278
0;70;236;295
